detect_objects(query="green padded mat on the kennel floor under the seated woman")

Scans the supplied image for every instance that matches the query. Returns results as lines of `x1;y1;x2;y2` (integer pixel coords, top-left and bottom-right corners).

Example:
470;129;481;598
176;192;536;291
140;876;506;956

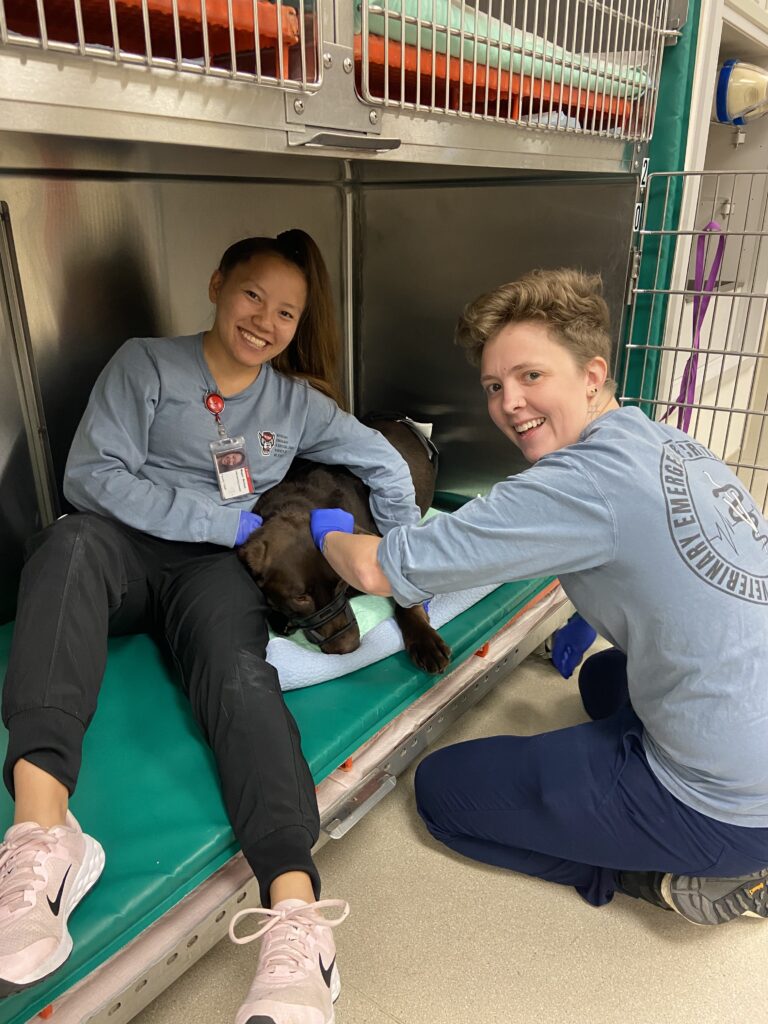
0;578;551;1024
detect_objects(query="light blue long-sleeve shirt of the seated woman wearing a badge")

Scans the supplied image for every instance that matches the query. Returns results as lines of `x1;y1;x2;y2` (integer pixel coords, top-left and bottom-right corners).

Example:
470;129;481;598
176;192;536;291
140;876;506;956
63;334;420;547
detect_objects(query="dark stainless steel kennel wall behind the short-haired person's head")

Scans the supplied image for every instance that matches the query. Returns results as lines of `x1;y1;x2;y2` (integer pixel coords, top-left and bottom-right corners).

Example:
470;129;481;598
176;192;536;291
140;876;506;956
356;180;635;495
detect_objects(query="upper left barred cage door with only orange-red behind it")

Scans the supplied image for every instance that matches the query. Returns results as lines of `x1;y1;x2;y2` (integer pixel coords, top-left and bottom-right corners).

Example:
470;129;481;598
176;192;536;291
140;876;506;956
0;0;325;91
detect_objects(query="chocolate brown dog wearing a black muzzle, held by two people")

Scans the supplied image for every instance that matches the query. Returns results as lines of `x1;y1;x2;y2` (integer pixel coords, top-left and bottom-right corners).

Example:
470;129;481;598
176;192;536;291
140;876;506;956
239;418;451;672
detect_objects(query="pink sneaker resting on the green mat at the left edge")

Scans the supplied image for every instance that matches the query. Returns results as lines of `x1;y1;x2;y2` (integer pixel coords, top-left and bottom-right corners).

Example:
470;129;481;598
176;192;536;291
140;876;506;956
0;813;104;995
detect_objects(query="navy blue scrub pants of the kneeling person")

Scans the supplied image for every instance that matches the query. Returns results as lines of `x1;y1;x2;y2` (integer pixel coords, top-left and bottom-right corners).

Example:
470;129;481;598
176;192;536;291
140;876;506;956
416;650;768;906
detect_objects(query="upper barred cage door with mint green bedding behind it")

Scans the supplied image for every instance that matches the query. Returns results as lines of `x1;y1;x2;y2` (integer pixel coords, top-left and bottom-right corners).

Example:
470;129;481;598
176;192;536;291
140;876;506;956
354;0;676;141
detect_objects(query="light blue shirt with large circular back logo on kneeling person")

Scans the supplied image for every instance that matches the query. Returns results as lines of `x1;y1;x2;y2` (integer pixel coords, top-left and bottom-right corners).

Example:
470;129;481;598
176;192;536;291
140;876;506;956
379;409;768;827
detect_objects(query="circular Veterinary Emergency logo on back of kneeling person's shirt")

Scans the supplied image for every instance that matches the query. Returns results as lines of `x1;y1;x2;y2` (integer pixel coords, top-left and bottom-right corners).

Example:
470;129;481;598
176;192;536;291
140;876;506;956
660;440;768;604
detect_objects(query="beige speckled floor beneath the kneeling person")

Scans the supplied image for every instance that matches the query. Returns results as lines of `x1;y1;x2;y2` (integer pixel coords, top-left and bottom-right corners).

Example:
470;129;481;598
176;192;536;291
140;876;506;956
135;638;768;1024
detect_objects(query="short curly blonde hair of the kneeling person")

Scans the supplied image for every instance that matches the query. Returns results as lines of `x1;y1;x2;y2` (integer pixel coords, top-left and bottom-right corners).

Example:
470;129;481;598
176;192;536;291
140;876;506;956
456;267;615;390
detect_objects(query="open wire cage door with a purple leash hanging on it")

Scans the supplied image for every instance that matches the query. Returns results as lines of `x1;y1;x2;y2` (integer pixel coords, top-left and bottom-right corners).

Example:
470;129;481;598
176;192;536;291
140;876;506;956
618;171;768;510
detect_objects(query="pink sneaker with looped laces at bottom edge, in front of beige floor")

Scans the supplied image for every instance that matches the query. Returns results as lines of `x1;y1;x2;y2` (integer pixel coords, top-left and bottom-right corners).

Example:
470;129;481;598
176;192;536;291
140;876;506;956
229;899;349;1024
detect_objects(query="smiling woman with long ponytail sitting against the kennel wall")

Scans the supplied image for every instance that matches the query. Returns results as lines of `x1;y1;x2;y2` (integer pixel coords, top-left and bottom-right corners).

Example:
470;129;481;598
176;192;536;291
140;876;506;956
0;228;420;1024
